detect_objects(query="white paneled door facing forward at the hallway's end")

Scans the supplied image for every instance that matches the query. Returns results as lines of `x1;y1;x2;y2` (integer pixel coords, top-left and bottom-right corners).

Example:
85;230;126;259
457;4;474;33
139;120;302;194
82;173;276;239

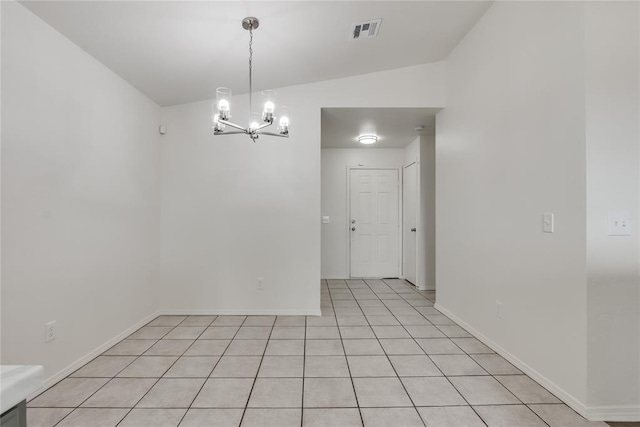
349;169;400;277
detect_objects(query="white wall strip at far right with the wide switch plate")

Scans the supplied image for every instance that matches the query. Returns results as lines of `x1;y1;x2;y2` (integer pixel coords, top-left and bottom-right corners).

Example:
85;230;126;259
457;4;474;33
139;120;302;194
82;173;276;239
585;2;640;420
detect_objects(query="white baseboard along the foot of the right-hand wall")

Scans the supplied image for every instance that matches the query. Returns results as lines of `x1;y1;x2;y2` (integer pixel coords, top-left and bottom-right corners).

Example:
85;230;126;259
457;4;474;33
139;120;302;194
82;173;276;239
434;303;592;421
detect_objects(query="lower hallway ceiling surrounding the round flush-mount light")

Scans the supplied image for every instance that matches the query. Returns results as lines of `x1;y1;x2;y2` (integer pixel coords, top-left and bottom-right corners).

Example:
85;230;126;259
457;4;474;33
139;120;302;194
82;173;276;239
321;108;440;148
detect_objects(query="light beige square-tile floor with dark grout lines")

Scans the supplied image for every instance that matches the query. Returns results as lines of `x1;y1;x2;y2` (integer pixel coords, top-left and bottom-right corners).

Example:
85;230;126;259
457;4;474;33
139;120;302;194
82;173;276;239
27;280;606;427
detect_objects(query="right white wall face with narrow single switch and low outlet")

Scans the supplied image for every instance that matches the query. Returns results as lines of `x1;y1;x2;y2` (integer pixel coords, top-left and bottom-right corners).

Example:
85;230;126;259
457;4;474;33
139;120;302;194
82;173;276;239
436;2;587;413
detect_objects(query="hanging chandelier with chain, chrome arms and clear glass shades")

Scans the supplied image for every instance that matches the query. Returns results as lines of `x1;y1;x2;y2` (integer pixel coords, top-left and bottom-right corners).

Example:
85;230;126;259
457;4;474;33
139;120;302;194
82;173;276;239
213;16;289;142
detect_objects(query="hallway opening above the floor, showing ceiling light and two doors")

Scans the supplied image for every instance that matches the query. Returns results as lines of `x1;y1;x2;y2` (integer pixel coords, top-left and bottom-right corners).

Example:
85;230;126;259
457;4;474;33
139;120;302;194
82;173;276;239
320;108;440;290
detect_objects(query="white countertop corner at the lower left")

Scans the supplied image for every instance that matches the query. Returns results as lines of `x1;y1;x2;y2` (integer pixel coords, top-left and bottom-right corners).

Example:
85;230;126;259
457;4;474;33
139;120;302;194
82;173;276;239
0;365;44;414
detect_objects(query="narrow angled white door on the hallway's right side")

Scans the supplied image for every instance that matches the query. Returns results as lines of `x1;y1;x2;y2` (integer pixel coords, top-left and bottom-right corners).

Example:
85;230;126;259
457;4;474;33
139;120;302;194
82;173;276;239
402;163;418;286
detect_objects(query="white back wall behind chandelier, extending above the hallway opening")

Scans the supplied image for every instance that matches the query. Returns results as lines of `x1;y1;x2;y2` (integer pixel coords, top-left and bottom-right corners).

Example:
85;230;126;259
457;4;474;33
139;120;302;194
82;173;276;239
160;63;445;313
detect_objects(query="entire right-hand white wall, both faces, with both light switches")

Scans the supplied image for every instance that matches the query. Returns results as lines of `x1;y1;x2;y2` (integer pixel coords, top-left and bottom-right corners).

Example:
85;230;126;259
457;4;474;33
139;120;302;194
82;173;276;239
437;2;640;421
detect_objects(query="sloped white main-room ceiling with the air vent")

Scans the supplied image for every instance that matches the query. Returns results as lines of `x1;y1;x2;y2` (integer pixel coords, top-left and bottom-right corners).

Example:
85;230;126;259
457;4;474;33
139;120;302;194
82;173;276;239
22;0;490;106
